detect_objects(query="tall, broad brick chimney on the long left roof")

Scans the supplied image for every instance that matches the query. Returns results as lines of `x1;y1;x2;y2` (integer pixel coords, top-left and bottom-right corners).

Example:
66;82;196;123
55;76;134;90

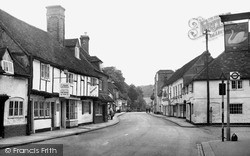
46;5;65;46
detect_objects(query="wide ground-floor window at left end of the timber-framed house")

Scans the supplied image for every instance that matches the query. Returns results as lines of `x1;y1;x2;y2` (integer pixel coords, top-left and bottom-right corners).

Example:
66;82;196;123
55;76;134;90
34;101;51;118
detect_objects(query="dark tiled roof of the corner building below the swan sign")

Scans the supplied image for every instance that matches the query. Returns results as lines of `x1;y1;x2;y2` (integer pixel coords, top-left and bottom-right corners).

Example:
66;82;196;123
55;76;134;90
194;51;250;80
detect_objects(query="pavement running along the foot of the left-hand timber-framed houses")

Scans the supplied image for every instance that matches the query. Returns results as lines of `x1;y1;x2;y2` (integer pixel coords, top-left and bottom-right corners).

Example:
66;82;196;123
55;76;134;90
0;112;125;149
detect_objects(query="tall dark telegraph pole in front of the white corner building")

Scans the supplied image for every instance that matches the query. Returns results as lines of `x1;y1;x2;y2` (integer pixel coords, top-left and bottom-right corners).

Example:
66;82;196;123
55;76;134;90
204;29;210;124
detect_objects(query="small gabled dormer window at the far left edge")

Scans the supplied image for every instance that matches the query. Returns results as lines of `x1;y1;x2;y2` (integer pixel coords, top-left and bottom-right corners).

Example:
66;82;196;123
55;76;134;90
0;49;14;74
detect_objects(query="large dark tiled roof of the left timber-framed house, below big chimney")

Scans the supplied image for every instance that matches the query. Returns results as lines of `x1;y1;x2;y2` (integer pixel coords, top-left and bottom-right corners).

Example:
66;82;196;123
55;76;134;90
0;9;98;77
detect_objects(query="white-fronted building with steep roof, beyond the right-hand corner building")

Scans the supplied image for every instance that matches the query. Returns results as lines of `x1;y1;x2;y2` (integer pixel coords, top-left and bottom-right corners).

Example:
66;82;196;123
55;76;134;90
162;52;212;118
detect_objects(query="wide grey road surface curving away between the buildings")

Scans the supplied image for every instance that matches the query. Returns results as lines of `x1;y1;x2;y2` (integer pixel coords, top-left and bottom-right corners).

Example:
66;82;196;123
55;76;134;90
29;112;216;156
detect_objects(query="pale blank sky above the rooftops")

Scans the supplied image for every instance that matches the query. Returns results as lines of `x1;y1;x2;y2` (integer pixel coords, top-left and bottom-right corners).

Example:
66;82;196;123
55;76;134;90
0;0;250;86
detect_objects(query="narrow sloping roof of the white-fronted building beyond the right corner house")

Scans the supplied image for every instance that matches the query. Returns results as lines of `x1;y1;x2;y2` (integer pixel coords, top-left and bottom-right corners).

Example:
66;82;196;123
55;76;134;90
164;52;205;86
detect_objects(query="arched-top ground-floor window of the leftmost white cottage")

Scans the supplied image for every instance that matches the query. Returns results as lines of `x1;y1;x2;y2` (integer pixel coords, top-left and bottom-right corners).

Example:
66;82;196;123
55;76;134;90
9;101;23;117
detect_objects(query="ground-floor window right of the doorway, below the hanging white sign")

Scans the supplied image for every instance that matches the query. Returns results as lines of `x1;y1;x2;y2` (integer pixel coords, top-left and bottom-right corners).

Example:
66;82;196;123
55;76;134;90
66;100;77;120
